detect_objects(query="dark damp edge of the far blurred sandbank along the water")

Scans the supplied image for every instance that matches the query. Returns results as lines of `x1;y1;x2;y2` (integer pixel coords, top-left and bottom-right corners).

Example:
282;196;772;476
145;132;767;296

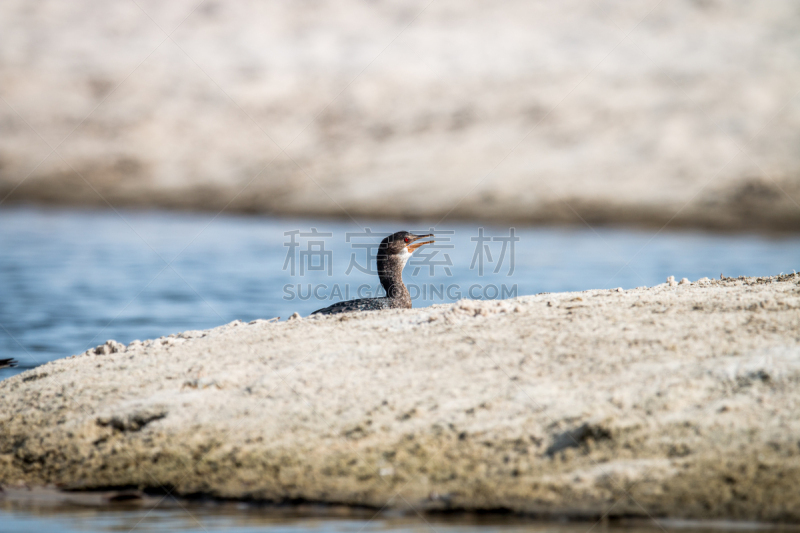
0;195;800;236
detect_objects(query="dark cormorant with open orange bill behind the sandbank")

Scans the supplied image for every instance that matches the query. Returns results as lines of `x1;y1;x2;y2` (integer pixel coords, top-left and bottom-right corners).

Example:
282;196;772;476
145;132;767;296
311;231;433;315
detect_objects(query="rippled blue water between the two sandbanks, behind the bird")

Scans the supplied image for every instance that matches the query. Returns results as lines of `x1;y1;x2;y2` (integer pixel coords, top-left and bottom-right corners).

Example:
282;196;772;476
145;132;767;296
0;207;800;378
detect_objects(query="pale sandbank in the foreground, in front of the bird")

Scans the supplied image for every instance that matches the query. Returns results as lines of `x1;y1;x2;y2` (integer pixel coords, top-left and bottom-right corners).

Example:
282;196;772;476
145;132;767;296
0;275;800;522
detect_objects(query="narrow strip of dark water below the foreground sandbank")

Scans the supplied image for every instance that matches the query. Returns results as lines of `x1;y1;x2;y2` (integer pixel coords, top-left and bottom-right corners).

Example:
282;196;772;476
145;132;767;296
0;500;780;533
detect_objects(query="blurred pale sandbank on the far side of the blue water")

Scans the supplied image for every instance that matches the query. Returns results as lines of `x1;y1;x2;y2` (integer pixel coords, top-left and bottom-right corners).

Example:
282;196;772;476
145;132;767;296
0;0;800;231
